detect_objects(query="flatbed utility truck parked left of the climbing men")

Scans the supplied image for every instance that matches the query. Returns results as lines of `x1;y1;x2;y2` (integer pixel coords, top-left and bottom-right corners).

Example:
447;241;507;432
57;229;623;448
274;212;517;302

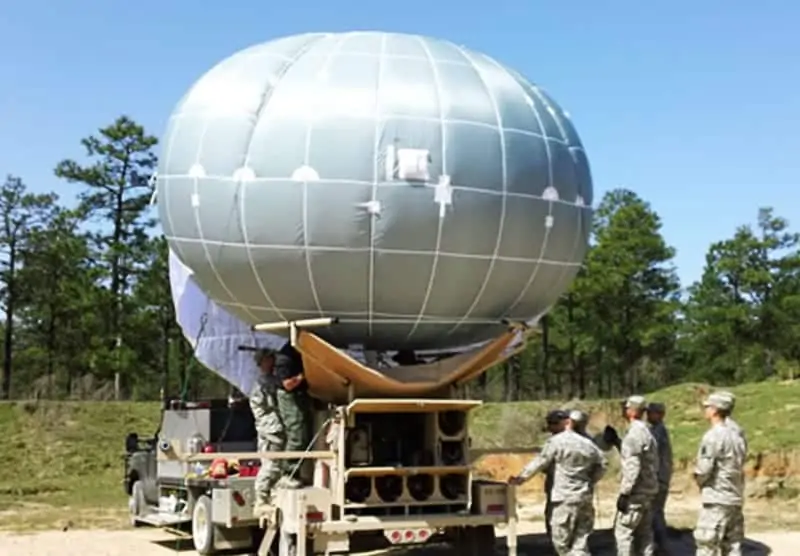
123;398;260;554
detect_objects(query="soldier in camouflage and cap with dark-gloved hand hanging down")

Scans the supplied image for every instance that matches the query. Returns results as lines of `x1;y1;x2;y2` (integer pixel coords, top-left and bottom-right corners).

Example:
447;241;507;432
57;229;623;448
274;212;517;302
614;396;658;556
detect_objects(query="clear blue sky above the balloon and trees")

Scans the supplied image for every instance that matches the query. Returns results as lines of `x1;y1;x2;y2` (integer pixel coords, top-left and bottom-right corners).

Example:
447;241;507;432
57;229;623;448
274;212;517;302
0;0;800;283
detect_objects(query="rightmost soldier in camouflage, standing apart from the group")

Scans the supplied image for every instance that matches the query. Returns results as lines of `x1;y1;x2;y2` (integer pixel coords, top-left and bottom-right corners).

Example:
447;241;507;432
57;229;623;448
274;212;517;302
694;393;746;556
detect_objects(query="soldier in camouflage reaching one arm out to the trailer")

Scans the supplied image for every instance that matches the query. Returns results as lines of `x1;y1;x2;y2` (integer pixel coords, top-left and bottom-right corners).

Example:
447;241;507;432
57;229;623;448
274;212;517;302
509;415;607;556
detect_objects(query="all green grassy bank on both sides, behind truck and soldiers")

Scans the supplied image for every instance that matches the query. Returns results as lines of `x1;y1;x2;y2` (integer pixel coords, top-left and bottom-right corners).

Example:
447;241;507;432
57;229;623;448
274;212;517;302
0;382;800;530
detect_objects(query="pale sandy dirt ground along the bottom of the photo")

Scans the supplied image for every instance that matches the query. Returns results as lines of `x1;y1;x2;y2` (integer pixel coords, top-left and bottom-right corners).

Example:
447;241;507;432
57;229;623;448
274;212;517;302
0;524;800;556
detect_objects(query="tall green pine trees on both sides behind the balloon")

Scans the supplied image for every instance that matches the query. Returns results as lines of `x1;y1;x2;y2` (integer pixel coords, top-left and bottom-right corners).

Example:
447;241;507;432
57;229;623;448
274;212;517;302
0;116;800;401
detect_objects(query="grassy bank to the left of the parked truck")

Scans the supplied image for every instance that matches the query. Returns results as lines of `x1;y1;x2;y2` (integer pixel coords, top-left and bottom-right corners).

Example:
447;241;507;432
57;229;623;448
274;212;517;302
0;402;159;528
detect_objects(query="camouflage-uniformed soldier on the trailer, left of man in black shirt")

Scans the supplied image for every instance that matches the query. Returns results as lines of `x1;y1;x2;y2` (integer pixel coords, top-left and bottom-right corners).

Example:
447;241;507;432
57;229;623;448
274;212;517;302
250;349;286;516
